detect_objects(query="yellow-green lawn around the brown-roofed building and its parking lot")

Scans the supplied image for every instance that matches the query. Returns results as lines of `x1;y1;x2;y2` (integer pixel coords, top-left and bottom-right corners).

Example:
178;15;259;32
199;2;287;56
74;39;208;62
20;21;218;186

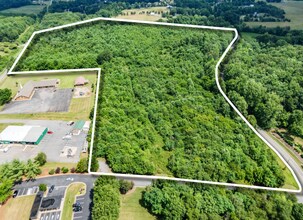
0;73;97;121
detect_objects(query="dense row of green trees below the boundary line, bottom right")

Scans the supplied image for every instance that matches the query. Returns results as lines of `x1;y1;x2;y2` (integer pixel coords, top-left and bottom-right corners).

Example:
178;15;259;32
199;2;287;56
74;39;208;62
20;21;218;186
142;181;303;220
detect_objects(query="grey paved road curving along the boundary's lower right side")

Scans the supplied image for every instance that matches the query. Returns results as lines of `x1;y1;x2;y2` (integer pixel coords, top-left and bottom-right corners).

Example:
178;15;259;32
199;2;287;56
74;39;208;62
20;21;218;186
258;130;303;203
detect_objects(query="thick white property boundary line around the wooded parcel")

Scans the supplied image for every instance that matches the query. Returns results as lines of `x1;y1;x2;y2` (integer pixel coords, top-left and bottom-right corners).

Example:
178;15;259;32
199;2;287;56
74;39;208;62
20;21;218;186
7;18;302;193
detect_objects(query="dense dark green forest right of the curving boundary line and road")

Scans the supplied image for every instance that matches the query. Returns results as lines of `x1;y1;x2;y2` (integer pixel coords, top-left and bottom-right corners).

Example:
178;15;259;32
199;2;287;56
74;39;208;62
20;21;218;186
223;37;303;137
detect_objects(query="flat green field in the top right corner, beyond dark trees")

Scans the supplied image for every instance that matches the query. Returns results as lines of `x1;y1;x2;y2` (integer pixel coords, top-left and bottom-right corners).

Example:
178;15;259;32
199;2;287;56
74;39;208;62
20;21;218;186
246;1;303;30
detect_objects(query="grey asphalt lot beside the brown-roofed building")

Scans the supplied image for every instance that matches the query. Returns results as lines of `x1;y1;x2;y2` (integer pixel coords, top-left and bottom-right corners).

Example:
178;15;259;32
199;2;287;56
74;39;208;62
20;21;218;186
0;88;73;114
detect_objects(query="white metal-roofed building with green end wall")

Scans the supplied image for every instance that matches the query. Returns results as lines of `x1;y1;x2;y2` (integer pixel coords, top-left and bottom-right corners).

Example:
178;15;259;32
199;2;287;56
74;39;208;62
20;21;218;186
0;125;47;145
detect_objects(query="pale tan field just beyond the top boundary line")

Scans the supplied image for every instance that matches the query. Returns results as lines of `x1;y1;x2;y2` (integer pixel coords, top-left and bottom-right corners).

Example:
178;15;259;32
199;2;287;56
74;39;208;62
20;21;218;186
117;7;168;21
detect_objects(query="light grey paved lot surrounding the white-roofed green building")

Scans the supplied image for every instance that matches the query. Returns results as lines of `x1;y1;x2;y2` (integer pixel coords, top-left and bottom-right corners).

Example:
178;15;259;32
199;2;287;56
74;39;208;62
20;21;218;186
0;119;86;164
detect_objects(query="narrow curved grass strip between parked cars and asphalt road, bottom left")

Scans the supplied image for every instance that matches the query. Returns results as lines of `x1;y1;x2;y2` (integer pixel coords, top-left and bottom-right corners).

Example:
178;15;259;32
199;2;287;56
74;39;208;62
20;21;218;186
61;183;85;220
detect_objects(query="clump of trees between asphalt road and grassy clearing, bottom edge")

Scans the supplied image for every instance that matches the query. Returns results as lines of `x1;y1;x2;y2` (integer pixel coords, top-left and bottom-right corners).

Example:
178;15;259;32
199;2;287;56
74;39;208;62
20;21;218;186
92;176;120;220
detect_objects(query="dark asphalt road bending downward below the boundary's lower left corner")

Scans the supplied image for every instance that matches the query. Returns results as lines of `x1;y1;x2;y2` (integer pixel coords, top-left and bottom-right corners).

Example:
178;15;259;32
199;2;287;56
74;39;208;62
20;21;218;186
14;174;97;220
